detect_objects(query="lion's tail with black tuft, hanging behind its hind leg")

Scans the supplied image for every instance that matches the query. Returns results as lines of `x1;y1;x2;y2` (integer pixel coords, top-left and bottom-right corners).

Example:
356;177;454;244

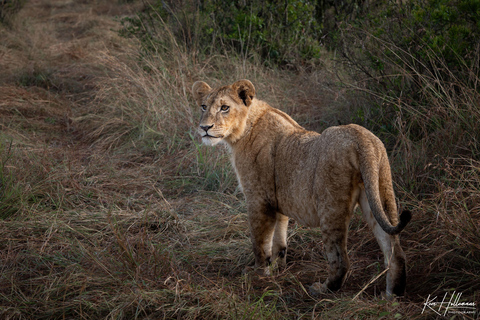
360;148;412;235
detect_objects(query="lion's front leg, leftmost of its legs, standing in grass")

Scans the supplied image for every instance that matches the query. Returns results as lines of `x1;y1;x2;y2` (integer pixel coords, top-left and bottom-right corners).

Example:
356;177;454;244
248;204;276;275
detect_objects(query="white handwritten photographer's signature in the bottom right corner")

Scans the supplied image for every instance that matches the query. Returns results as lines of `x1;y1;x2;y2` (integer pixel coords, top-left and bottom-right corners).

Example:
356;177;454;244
422;291;477;316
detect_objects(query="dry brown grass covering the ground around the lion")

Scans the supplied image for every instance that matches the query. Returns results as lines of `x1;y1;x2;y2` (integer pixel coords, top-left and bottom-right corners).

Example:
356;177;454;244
0;0;480;319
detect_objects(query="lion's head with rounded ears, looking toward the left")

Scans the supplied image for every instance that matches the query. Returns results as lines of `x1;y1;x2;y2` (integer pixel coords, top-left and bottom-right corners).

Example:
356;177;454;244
193;80;255;146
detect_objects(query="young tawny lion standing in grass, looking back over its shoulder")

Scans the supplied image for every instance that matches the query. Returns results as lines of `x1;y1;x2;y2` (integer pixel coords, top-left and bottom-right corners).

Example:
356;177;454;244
192;80;411;297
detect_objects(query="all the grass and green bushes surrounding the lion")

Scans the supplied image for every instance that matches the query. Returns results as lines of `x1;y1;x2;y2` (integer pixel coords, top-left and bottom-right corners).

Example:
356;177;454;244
0;0;480;319
